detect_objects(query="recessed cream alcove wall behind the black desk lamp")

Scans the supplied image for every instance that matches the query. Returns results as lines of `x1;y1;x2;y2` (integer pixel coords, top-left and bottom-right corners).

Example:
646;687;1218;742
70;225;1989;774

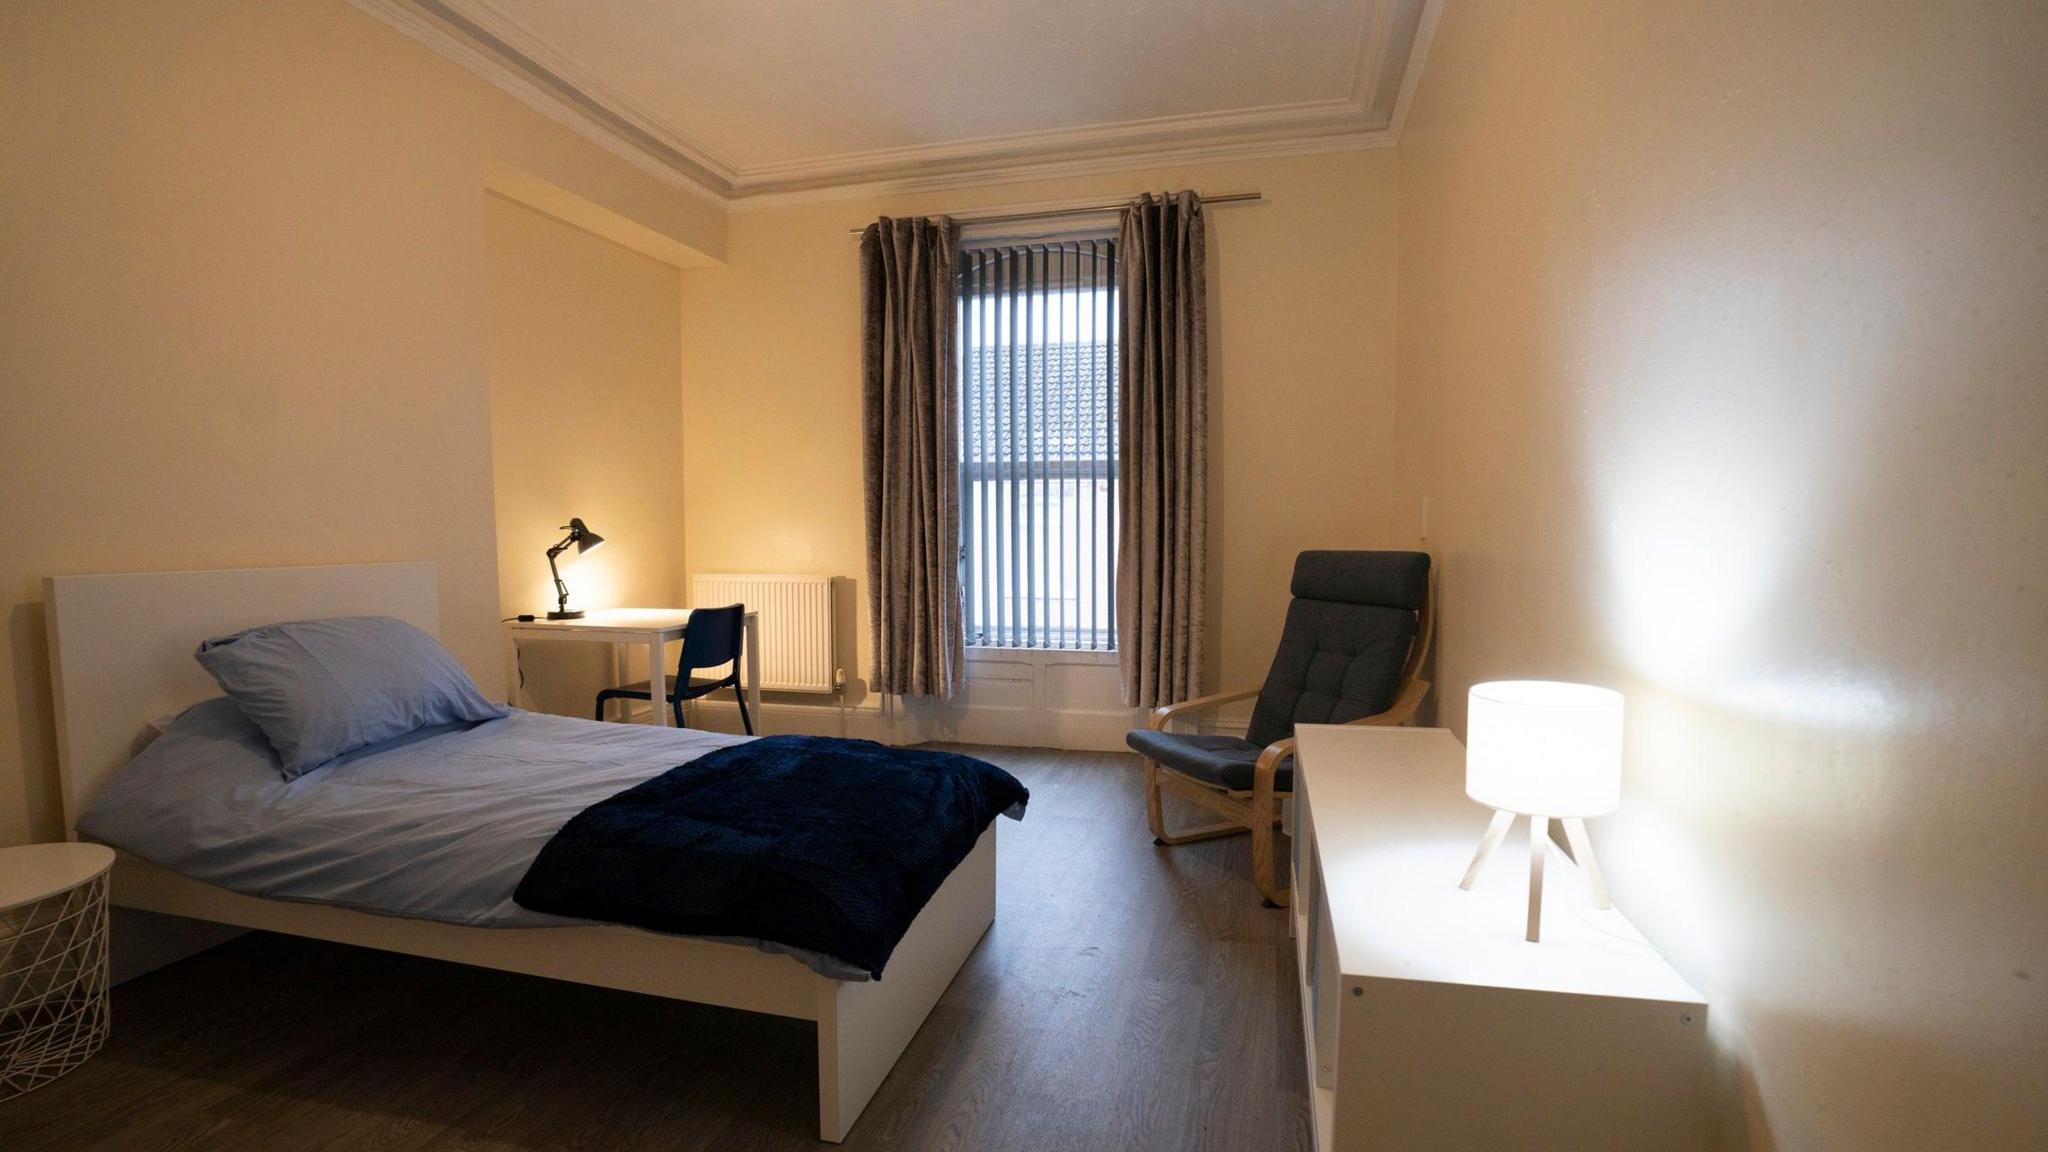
483;195;684;715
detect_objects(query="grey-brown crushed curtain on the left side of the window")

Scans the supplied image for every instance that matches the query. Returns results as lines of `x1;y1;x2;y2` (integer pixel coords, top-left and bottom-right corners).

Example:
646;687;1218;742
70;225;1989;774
860;217;967;697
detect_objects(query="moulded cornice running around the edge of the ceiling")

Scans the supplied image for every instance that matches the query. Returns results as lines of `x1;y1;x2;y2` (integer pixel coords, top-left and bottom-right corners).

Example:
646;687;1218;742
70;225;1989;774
350;0;1444;209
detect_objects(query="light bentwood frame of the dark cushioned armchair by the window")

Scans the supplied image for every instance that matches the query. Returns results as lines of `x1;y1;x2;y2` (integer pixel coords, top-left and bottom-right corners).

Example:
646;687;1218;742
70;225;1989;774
1145;568;1436;908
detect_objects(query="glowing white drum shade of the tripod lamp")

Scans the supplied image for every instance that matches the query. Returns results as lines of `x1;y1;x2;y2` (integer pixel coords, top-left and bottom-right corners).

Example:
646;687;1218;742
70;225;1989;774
1464;681;1622;818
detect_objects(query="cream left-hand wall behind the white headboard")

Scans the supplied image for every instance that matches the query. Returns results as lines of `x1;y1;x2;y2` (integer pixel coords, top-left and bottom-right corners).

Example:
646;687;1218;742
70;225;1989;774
0;0;723;845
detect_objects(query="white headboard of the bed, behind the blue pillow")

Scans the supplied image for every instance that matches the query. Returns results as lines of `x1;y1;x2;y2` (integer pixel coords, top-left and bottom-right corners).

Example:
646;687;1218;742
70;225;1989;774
43;560;440;828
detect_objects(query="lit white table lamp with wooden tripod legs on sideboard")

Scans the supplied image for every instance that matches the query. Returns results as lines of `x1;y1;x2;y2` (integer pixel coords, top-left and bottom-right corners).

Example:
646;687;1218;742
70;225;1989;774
1458;681;1622;943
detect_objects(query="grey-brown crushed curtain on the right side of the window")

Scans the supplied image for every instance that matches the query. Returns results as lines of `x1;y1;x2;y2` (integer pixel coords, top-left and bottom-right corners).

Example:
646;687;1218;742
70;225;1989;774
1116;193;1208;707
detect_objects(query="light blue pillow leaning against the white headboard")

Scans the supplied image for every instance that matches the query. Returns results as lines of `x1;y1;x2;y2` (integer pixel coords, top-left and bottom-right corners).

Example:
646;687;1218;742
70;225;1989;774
195;617;510;779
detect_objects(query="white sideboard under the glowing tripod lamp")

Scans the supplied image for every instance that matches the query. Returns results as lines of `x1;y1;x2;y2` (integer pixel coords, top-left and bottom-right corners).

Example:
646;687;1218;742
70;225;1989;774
1292;726;1708;1152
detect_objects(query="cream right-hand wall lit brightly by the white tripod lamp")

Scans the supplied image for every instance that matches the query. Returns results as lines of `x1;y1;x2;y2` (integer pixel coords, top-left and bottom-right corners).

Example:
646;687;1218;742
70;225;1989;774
1372;0;2048;1150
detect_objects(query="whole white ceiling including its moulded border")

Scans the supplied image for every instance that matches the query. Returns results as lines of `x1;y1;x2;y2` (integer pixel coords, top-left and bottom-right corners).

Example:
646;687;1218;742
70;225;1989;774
356;0;1440;199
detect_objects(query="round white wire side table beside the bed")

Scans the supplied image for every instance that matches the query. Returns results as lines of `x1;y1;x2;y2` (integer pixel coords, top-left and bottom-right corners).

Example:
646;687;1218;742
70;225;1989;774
0;845;115;1101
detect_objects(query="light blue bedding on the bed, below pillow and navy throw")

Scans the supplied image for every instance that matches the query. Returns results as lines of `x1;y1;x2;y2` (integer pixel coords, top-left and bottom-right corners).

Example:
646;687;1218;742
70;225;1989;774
78;699;866;980
